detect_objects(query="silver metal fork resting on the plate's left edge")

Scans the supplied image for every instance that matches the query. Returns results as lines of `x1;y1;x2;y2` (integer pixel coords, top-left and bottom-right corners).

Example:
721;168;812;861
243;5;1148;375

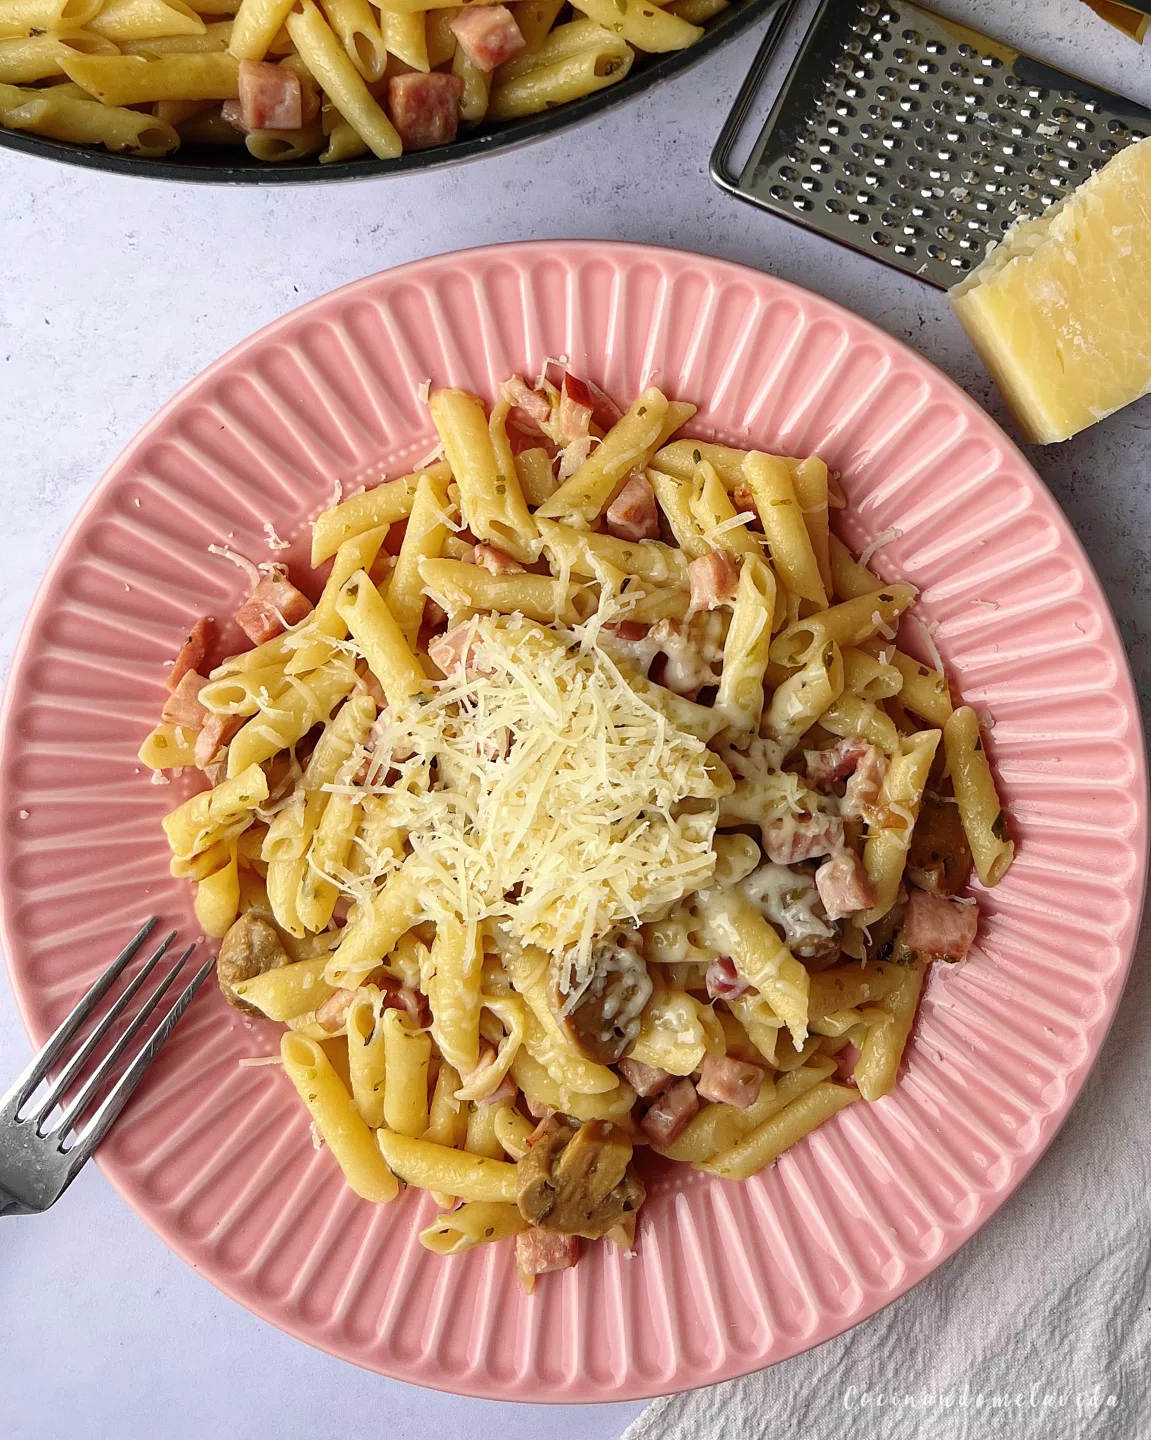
0;916;215;1215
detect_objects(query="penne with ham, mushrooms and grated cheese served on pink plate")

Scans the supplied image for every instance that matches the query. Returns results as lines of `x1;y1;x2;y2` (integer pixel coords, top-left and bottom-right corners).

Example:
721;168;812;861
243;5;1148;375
140;365;1013;1289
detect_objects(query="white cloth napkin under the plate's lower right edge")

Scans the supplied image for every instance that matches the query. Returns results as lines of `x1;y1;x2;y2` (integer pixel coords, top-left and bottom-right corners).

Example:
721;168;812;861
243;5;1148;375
622;919;1151;1440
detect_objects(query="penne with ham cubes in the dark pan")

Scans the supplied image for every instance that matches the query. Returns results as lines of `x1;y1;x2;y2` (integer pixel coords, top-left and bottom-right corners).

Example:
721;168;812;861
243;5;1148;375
0;0;711;164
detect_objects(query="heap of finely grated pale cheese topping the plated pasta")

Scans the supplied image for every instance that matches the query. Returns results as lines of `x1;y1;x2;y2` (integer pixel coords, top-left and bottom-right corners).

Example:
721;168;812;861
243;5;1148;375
333;616;727;989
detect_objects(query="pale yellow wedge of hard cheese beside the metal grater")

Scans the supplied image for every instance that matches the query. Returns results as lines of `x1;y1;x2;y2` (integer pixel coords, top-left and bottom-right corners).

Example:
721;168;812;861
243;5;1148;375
948;138;1151;445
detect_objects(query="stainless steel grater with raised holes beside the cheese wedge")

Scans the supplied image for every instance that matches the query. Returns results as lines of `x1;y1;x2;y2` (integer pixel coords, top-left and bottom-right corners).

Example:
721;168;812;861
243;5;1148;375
712;0;1151;289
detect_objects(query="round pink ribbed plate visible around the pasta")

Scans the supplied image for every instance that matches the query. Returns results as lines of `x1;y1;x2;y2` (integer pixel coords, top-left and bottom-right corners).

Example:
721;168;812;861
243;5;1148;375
0;242;1147;1401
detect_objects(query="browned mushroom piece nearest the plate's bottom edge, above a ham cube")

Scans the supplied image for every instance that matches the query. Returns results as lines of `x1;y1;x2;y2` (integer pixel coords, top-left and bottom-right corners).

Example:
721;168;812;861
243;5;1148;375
517;1116;645;1240
